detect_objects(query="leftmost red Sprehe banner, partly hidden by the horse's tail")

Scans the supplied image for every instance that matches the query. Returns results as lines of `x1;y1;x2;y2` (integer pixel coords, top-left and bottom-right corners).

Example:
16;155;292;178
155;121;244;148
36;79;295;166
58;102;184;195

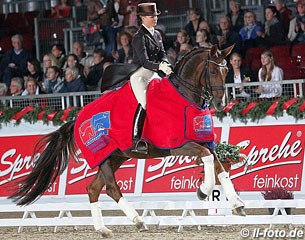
0;135;59;197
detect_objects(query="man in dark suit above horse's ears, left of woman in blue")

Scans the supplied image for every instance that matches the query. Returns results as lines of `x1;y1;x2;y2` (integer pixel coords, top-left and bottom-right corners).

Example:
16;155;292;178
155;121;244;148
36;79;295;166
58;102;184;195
217;16;242;53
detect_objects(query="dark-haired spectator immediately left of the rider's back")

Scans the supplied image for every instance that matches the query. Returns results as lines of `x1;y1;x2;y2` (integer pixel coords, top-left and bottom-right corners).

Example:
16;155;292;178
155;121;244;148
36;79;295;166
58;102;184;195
112;32;133;63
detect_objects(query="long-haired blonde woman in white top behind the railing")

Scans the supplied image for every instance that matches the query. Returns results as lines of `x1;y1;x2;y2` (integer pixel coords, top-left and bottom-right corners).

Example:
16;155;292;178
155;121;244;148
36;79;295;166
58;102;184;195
256;50;283;98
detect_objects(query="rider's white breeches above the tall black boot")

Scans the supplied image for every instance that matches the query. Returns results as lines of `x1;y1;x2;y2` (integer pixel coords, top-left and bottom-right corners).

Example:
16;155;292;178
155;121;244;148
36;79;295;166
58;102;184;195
130;67;155;109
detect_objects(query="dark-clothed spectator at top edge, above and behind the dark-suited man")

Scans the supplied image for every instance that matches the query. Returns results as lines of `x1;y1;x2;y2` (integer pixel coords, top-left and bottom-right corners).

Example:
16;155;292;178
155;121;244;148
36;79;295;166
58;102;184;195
227;0;244;33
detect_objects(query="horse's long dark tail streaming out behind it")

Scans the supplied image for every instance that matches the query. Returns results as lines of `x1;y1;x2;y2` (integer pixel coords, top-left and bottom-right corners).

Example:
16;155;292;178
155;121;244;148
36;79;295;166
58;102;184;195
9;120;77;205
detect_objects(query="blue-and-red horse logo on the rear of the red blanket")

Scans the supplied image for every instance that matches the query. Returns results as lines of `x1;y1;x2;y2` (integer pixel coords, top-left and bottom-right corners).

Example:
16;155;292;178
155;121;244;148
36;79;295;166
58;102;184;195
79;112;110;153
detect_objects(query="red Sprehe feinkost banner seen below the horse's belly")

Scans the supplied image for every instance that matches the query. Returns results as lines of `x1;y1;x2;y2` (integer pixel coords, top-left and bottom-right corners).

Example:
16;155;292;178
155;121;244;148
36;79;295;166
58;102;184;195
142;128;221;193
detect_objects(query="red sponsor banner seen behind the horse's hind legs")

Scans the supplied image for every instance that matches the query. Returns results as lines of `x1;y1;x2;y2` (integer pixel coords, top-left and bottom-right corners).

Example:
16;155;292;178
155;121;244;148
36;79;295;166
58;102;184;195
65;156;138;195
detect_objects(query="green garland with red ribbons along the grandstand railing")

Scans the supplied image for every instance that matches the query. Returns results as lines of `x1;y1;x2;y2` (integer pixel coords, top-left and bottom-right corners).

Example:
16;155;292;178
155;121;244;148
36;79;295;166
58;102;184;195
0;98;305;127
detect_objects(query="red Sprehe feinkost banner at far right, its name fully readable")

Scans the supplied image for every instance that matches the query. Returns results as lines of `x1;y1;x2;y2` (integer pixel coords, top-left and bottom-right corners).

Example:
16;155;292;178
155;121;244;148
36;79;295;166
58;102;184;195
229;125;305;191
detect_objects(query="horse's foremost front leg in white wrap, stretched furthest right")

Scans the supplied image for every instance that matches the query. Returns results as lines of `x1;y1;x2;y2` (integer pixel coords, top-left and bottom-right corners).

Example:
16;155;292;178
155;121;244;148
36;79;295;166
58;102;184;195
214;154;246;216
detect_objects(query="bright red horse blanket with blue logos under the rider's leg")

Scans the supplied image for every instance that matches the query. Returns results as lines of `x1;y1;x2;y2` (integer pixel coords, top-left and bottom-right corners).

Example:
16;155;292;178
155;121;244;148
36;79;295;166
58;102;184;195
74;78;215;168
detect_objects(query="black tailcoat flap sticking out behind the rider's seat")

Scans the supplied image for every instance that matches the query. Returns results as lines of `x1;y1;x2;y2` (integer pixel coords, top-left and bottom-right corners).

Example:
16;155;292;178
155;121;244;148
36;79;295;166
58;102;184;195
101;63;140;92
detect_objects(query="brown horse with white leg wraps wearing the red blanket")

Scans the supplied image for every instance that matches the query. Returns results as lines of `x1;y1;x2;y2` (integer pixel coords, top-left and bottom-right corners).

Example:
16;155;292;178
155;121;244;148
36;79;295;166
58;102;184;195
9;45;245;238
